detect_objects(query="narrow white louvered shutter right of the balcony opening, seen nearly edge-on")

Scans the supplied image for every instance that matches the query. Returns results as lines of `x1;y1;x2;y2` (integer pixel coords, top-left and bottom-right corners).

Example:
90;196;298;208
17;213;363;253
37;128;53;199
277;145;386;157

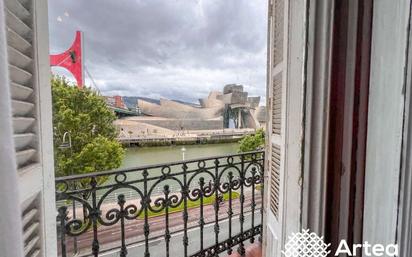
266;0;288;253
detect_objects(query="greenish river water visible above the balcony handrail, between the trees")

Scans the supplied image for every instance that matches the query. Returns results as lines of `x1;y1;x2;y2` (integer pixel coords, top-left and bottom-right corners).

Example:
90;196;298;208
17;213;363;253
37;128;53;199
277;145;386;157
120;143;238;168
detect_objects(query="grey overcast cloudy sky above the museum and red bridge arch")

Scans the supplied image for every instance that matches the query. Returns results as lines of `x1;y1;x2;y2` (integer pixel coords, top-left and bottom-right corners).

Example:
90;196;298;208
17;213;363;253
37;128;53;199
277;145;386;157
48;0;267;103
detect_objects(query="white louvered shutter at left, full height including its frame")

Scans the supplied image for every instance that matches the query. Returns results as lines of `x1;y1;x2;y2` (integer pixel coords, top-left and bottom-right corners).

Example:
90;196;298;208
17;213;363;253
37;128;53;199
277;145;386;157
3;0;57;257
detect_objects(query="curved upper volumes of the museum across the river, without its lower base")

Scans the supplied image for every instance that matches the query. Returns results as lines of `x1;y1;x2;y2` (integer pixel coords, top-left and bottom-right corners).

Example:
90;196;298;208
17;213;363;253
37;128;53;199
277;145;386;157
134;85;264;130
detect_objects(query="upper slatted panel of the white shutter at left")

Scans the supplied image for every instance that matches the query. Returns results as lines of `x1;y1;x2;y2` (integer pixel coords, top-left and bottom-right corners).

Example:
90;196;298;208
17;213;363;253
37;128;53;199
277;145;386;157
5;0;38;170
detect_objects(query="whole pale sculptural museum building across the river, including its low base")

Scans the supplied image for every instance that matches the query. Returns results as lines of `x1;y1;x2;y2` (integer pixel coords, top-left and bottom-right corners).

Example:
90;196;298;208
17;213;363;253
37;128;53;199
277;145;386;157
115;85;266;141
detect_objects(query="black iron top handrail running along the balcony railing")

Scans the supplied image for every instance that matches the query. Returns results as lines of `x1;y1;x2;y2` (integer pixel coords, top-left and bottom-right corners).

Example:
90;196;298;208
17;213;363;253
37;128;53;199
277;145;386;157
55;150;265;183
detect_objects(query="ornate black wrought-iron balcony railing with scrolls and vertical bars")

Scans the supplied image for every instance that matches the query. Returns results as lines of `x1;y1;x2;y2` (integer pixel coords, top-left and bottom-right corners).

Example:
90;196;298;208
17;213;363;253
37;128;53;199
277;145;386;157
56;151;264;257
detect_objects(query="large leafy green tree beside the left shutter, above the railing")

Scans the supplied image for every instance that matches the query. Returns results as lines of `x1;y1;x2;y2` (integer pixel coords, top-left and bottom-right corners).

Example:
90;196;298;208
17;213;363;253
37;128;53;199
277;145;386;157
52;77;124;180
